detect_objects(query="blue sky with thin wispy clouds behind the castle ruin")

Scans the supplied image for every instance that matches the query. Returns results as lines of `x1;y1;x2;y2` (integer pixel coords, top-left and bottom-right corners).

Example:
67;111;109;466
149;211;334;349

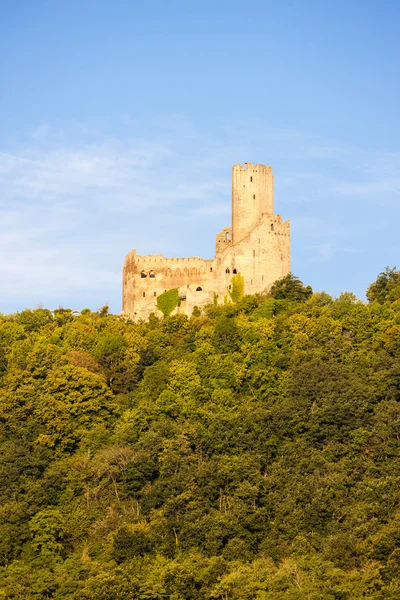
0;0;400;313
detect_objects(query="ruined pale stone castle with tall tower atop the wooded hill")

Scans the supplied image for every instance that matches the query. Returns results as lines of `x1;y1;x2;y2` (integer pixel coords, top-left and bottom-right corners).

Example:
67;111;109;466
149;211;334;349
122;163;290;321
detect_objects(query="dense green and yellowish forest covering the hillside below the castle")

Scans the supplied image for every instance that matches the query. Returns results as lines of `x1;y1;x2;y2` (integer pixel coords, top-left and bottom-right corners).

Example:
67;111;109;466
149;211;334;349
0;268;400;600
